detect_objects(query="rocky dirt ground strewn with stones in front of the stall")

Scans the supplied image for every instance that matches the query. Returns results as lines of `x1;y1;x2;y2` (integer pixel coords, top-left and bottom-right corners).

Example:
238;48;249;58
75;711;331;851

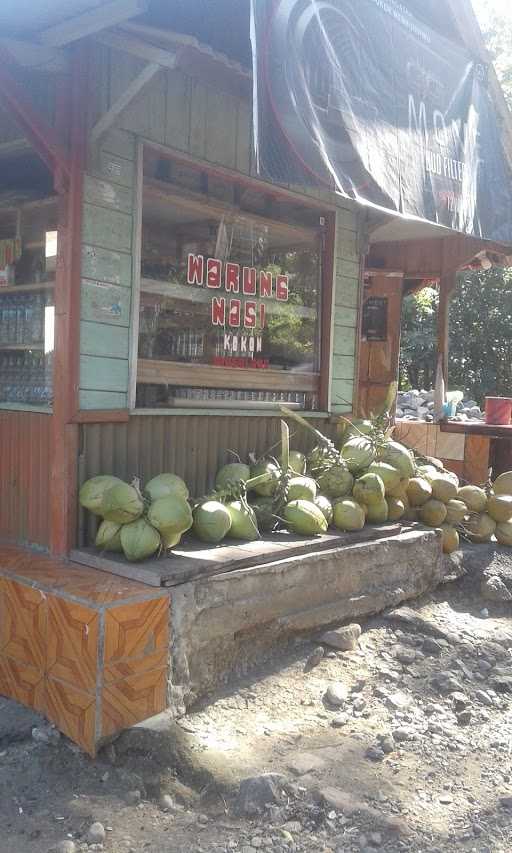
0;544;512;853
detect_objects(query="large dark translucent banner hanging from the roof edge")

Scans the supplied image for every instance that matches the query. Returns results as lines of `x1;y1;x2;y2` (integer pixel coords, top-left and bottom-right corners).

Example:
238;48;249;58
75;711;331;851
251;0;512;243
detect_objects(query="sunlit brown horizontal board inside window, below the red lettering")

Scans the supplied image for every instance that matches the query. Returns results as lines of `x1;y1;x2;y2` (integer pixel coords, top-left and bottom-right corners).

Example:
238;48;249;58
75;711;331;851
138;359;318;391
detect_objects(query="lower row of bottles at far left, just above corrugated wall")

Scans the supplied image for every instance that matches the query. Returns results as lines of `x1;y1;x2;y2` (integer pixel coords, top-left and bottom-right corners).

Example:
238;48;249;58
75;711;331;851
0;350;53;406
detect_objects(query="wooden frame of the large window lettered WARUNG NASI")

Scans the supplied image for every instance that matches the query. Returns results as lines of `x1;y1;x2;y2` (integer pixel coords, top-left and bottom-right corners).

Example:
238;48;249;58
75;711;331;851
128;141;336;416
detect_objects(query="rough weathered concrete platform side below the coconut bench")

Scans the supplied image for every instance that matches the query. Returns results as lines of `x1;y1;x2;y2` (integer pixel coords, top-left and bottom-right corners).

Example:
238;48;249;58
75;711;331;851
169;528;446;713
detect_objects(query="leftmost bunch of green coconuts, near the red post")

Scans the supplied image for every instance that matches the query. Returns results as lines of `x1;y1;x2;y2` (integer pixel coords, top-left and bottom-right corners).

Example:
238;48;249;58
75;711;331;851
79;474;193;562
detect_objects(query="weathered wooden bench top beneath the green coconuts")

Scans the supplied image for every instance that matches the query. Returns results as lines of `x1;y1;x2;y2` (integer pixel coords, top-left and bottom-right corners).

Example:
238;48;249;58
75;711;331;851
70;524;402;586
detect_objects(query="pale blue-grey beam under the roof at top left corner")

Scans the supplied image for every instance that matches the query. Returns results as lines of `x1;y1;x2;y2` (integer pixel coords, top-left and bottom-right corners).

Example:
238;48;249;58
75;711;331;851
40;0;148;47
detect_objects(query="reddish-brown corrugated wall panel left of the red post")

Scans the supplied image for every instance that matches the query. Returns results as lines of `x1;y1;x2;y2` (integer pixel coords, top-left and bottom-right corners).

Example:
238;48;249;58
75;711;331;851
0;412;52;548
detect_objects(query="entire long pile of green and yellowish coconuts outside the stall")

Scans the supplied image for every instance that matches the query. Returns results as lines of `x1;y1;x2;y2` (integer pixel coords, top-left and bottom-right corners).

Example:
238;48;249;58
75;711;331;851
80;407;512;562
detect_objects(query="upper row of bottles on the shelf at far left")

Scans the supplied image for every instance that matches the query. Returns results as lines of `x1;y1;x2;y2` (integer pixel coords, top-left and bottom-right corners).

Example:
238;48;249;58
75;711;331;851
0;290;47;347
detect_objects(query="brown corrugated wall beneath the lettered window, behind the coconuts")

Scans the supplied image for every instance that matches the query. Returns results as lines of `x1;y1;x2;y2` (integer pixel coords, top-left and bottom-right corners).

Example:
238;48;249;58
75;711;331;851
80;415;335;541
